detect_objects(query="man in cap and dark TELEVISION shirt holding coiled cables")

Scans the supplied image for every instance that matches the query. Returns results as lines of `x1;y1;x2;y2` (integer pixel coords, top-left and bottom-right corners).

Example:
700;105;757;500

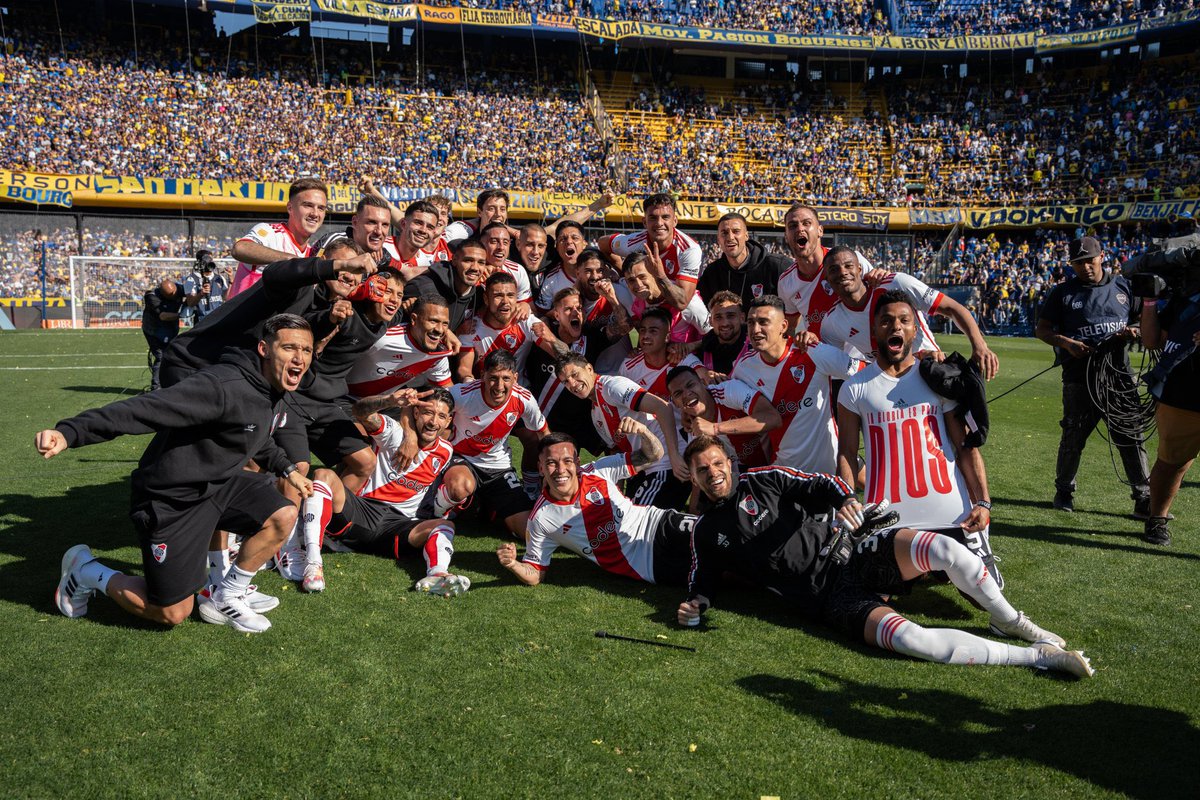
1034;236;1150;519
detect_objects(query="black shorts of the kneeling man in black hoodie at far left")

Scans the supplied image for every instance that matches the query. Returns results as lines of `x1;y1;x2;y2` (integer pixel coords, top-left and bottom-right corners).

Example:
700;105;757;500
130;473;292;606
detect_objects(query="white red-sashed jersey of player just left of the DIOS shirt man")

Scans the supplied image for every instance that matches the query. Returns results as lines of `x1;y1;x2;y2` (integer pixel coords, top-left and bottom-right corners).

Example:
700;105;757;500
730;343;862;475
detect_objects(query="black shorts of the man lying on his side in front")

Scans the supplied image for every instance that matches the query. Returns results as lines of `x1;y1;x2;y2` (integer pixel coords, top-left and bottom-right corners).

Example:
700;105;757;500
820;528;916;640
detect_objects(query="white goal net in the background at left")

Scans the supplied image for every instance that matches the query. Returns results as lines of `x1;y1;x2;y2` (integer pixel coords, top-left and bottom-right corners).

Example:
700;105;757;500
70;255;238;327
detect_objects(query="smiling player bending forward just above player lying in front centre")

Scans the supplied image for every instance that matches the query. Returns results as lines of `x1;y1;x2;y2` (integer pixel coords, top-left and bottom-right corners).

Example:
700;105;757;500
557;353;690;509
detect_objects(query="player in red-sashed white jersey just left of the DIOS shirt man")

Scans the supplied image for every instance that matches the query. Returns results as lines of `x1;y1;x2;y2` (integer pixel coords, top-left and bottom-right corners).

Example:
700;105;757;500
730;295;860;473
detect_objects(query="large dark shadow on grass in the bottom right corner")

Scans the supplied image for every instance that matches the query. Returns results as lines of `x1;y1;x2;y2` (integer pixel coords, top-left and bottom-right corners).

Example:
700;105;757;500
737;667;1200;800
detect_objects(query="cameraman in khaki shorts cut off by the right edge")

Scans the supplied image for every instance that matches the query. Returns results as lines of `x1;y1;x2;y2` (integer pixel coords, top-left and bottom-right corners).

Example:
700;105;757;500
1141;287;1200;545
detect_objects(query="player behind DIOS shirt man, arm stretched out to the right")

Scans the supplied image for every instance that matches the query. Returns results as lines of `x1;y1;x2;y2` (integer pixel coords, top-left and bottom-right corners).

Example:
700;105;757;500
821;247;1000;380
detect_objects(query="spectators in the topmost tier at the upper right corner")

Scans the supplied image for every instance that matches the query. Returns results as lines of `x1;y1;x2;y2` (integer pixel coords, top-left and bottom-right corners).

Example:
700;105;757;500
896;0;1195;37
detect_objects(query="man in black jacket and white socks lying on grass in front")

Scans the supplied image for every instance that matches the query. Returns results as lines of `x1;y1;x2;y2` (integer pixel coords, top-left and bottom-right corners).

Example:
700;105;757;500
677;437;1093;678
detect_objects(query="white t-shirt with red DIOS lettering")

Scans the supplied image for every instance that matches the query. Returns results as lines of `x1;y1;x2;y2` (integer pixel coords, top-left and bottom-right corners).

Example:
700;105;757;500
838;363;971;529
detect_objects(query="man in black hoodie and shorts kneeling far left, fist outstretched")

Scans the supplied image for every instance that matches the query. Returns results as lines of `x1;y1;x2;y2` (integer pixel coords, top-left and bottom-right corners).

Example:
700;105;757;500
36;314;313;633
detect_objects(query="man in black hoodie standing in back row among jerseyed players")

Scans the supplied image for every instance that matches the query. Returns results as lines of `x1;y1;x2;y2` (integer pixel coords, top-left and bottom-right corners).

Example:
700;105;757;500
696;211;788;311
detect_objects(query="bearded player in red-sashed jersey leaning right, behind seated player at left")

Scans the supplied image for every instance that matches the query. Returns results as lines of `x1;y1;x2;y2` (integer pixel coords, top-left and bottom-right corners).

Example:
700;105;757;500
346;295;452;397
